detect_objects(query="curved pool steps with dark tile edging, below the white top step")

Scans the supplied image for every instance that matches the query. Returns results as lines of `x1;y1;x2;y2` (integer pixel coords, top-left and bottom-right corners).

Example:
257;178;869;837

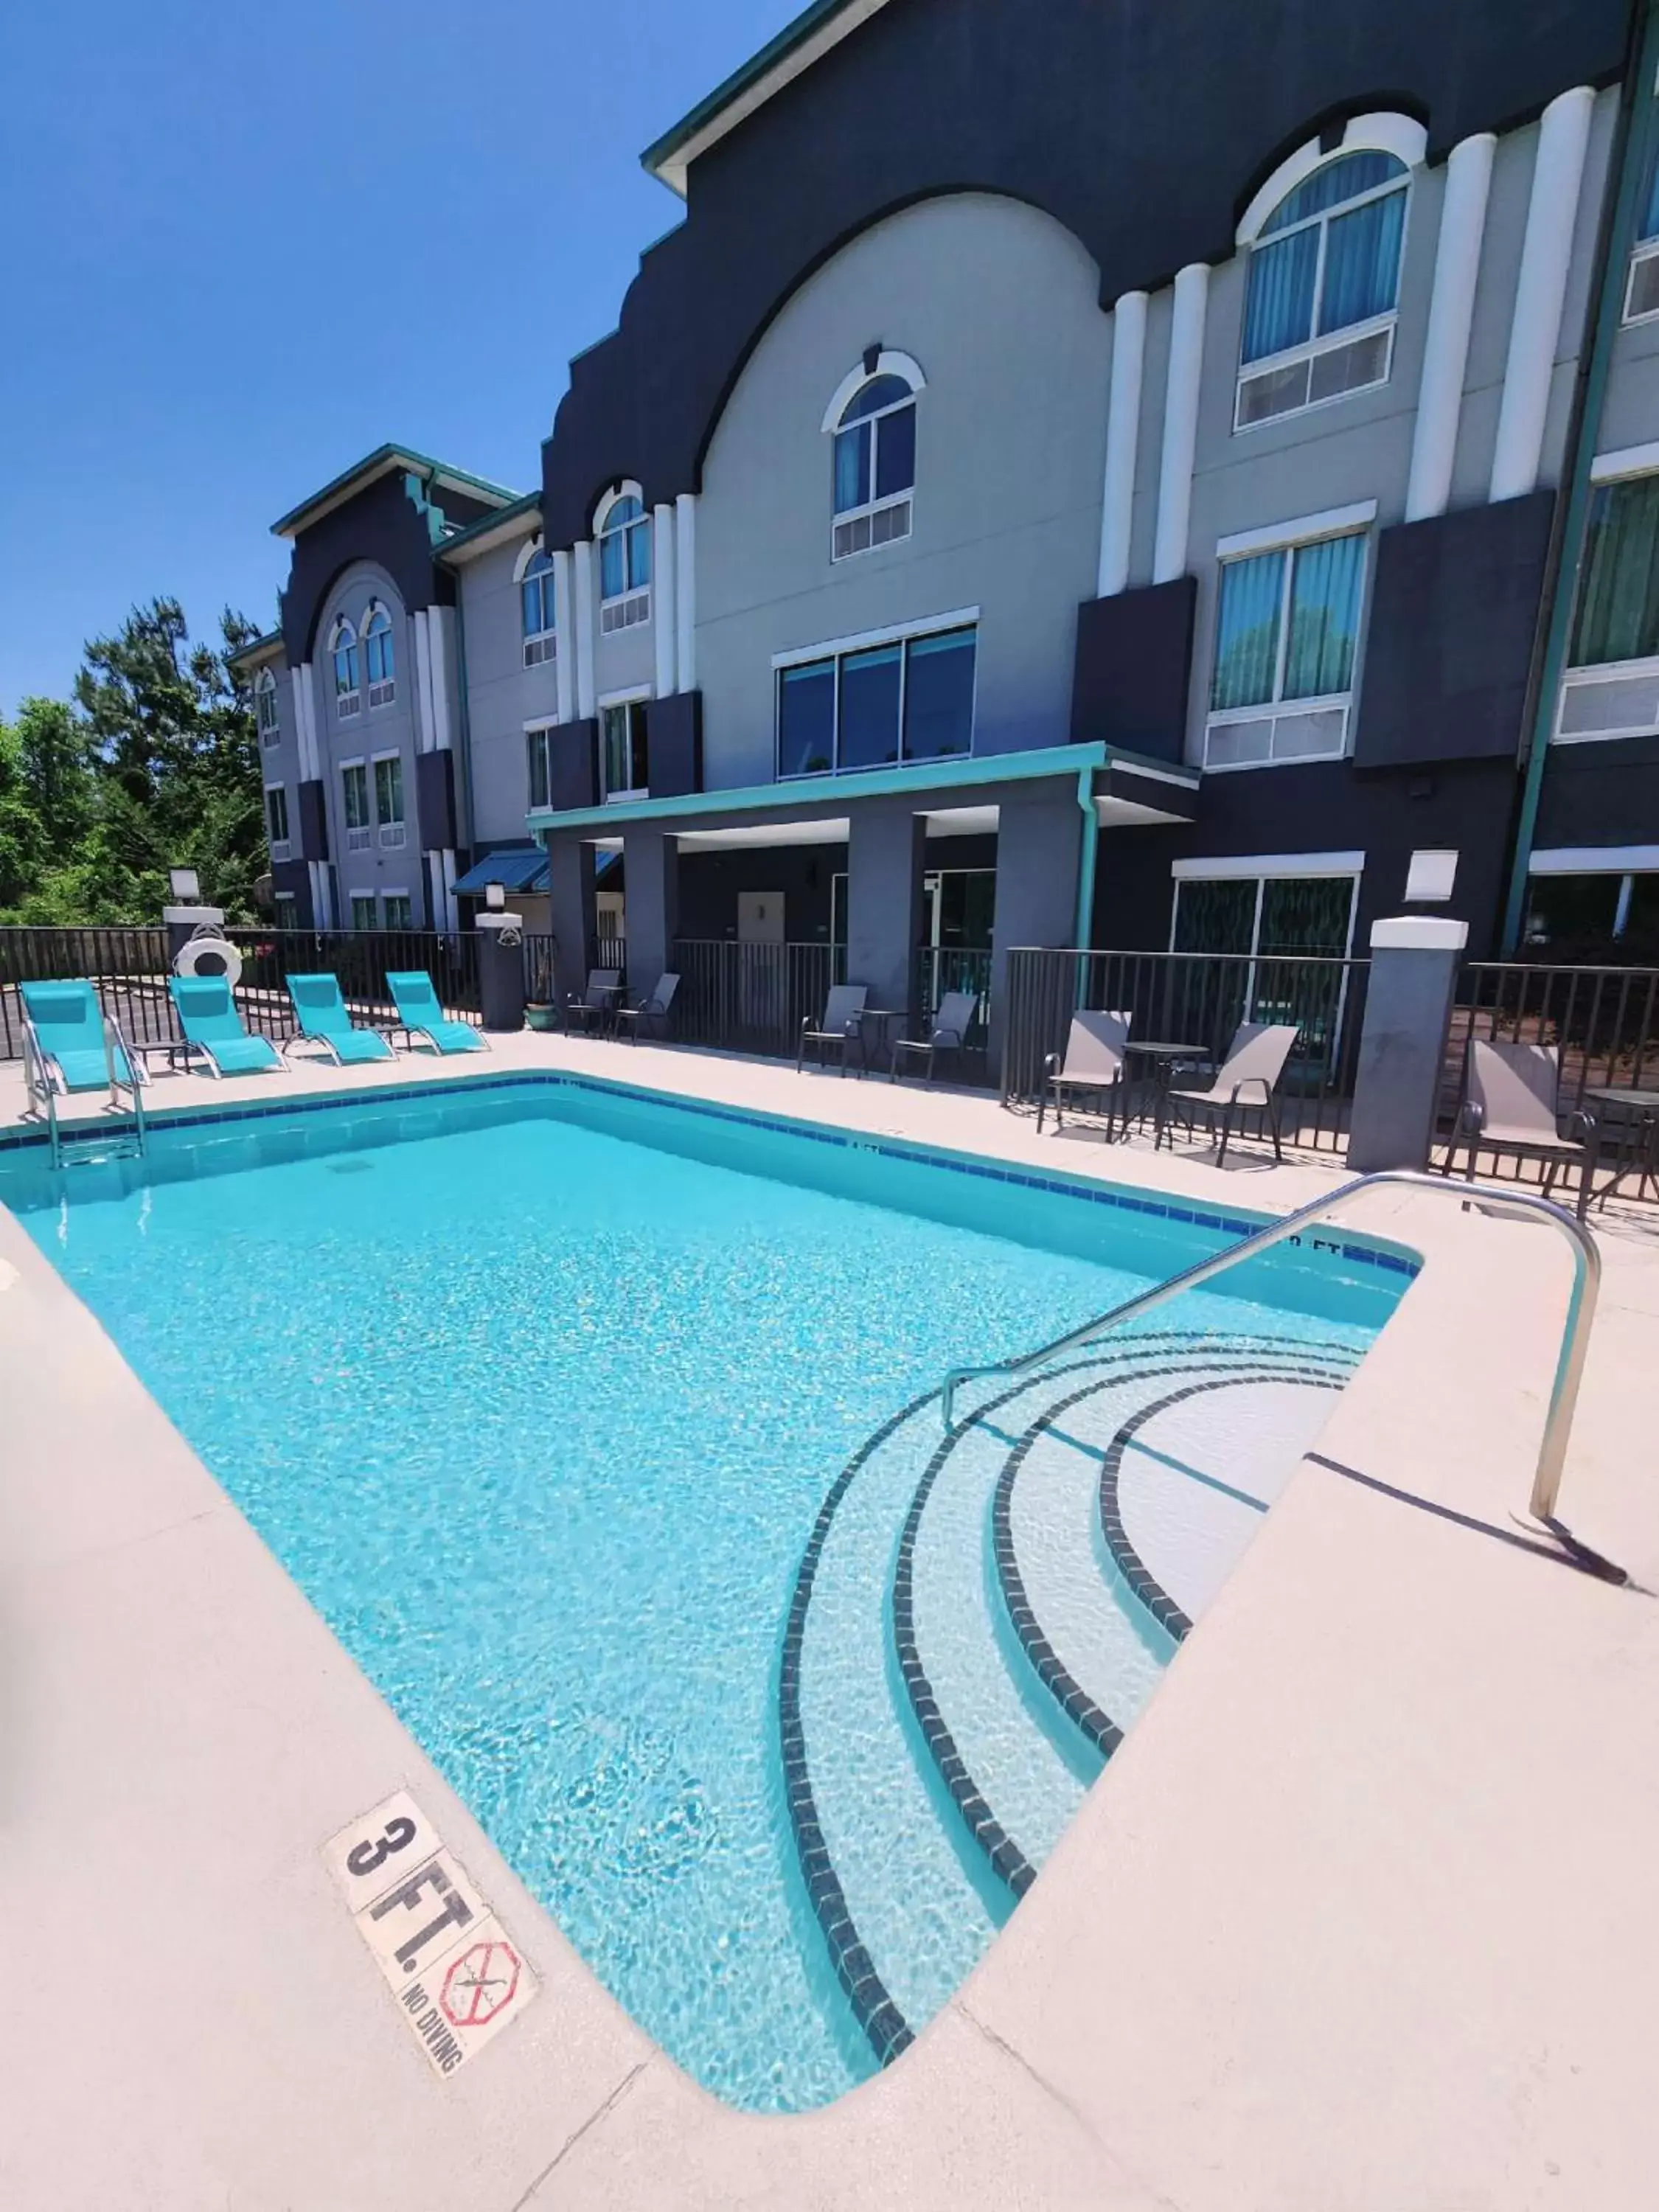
779;1327;1358;2064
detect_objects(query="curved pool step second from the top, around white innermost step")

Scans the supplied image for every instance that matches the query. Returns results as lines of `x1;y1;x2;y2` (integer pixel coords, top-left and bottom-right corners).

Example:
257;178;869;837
991;1336;1336;1756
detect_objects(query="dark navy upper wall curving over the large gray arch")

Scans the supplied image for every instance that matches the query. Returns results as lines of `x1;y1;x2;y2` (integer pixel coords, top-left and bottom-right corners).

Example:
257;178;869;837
542;0;1630;544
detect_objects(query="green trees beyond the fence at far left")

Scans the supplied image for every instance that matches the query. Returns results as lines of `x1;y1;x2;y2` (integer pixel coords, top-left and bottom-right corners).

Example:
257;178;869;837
0;599;265;922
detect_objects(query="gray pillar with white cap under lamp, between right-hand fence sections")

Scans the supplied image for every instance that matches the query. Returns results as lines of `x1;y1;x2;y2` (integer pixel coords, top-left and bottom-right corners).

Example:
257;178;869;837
1347;914;1469;1175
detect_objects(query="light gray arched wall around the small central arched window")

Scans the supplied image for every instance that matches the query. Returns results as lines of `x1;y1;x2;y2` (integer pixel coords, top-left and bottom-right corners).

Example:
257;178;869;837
695;192;1110;787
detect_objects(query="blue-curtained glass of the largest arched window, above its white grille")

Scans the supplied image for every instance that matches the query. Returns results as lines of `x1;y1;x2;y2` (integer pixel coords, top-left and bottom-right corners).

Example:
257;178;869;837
1243;150;1407;363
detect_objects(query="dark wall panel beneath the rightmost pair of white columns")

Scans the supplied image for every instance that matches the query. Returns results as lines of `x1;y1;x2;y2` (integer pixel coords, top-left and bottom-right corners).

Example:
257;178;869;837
1354;491;1555;768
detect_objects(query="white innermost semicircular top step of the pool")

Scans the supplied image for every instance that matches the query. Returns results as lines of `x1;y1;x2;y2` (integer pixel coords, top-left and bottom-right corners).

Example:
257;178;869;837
1102;1367;1343;1621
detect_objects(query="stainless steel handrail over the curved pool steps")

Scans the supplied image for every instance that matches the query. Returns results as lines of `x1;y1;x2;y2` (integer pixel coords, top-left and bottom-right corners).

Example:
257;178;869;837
940;1168;1601;1522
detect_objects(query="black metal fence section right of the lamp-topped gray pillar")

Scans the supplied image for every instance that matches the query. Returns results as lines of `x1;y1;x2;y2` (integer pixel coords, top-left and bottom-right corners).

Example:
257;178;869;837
1436;960;1659;1197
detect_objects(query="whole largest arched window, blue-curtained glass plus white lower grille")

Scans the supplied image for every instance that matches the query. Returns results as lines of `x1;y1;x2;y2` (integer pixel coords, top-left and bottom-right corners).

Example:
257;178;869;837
1234;146;1409;429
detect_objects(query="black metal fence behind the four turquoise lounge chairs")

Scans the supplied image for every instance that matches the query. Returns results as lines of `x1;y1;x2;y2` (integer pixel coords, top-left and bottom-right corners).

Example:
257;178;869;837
0;927;480;1060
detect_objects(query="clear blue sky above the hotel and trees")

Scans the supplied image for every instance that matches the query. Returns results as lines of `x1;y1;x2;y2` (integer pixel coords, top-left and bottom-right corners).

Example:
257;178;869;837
0;0;799;712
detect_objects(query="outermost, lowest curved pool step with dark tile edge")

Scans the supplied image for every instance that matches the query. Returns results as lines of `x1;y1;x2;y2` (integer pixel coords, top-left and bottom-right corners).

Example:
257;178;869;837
776;1394;998;2064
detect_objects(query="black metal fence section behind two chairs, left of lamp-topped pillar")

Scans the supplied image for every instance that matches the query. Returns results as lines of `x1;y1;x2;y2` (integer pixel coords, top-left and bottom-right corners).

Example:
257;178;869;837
1002;951;1369;1152
